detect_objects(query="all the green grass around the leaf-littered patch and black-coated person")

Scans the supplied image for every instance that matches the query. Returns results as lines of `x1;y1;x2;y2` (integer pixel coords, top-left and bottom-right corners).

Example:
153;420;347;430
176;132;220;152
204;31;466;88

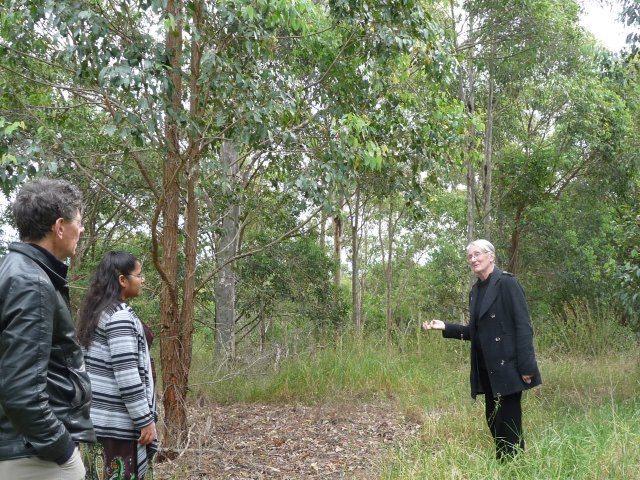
185;334;640;480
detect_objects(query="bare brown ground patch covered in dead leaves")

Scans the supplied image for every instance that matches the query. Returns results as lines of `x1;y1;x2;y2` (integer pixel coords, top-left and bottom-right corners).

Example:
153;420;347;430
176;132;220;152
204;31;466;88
155;402;420;480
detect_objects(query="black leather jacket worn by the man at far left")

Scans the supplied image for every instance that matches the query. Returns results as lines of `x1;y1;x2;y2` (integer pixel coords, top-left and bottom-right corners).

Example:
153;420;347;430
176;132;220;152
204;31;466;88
0;242;96;461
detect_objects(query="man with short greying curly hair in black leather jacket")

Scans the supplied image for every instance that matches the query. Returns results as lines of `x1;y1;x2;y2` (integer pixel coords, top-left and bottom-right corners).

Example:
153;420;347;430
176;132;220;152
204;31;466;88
0;179;96;480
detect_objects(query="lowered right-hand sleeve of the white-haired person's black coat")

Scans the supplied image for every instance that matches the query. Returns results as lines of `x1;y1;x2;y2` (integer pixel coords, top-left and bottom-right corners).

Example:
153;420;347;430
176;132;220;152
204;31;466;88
502;276;537;375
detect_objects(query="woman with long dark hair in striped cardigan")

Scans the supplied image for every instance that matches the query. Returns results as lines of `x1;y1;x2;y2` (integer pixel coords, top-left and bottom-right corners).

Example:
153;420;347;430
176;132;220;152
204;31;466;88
78;251;157;480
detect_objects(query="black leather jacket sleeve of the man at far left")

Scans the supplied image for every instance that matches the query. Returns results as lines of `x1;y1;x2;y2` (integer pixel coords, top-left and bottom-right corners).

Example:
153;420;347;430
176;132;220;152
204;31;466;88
0;276;72;461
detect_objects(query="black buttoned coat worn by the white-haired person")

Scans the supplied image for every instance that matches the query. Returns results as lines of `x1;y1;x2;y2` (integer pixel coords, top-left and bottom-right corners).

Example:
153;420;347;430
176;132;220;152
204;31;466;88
442;267;542;398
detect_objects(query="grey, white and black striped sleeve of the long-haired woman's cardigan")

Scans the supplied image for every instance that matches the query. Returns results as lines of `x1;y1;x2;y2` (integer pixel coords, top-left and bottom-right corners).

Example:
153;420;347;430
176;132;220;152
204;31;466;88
105;310;153;429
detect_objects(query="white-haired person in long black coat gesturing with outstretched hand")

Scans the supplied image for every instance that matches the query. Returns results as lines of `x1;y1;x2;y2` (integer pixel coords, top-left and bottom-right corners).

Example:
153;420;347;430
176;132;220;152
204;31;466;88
422;240;542;460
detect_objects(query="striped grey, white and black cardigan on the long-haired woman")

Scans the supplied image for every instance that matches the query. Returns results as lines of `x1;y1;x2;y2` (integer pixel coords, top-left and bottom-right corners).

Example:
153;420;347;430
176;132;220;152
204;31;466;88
85;303;155;440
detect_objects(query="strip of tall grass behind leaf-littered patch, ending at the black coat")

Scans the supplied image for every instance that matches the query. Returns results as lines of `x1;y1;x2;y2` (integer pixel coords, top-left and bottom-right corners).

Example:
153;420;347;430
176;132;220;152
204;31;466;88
191;335;468;403
